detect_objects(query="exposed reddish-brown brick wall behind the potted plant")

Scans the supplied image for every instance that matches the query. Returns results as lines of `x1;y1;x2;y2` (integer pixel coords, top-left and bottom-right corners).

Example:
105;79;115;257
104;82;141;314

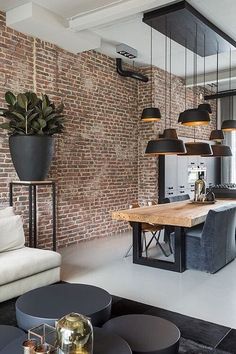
0;14;216;248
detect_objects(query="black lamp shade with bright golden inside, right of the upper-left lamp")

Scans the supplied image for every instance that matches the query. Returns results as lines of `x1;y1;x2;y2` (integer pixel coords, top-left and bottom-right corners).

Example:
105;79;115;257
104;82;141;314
178;108;210;127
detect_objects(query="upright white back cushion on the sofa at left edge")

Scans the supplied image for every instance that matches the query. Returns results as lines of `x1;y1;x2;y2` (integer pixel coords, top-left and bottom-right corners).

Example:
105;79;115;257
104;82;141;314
0;215;25;252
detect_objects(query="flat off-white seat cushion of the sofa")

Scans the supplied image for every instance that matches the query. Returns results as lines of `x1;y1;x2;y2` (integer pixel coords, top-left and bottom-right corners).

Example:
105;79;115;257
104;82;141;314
0;247;61;285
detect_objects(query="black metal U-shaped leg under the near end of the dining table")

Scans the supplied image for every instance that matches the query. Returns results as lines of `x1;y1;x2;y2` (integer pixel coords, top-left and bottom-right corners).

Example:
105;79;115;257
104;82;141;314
132;222;185;273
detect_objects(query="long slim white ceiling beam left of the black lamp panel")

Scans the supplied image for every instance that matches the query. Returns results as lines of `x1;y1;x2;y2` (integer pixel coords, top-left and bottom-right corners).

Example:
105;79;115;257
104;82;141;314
68;0;171;31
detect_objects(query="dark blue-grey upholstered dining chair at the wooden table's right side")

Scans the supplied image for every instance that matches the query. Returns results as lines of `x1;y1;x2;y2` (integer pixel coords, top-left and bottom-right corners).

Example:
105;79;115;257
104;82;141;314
171;205;236;273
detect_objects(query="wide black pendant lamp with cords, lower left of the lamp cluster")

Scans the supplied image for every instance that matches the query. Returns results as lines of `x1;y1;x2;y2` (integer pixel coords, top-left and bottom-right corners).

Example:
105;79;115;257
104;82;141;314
145;19;186;156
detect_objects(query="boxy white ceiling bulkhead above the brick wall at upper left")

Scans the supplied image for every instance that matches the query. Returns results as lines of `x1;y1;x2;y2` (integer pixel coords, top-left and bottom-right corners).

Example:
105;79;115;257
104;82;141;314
6;2;101;53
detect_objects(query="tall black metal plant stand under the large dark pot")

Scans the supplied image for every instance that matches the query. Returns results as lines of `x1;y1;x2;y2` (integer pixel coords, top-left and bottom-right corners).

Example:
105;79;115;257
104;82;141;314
9;181;57;251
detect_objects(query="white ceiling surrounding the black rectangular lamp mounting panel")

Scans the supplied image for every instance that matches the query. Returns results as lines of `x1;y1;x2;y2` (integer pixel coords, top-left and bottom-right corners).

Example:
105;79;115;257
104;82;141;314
0;0;236;86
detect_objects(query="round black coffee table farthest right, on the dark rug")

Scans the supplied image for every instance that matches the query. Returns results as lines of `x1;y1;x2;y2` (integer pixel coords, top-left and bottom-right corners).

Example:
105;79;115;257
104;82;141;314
103;315;180;354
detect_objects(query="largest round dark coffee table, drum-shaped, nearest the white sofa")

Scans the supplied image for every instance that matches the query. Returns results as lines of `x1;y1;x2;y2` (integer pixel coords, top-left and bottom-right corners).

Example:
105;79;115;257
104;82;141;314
16;284;112;331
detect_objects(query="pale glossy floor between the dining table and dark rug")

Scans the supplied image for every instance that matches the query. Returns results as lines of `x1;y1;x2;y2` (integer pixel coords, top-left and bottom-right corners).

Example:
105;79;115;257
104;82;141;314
61;234;236;328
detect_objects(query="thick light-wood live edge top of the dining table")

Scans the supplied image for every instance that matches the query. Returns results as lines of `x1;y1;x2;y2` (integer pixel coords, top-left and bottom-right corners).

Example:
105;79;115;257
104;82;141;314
112;199;236;227
